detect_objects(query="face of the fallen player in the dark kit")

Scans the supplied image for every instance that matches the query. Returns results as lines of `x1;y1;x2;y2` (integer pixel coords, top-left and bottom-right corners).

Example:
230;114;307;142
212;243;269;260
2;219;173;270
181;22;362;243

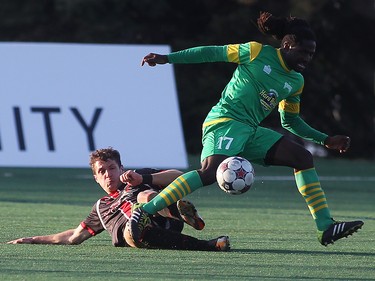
94;159;122;193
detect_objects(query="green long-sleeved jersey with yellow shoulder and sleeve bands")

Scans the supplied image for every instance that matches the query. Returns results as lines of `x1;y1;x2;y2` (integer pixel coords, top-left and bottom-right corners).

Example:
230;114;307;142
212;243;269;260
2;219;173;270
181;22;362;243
168;42;327;144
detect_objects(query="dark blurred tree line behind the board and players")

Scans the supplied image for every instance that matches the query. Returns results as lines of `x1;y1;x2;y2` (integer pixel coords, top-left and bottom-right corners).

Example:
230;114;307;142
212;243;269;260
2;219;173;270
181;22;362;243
0;0;375;159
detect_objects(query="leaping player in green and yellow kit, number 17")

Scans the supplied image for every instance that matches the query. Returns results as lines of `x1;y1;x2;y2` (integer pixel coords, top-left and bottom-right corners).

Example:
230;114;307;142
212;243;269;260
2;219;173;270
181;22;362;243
130;12;364;246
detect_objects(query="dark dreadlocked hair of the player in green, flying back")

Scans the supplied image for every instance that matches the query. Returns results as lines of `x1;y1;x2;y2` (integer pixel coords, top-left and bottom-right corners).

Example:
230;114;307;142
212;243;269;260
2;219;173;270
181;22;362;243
257;12;316;45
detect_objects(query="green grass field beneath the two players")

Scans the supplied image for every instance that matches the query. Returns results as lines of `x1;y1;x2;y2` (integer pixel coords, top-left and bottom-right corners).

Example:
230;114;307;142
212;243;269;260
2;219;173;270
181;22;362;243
0;156;375;281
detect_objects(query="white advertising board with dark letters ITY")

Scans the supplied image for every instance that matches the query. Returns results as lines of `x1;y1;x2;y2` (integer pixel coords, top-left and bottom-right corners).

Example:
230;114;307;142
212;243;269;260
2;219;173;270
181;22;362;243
0;43;187;168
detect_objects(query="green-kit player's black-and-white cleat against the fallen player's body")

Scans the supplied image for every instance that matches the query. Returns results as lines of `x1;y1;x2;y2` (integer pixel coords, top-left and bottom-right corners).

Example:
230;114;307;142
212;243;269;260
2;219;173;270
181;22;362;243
129;203;151;248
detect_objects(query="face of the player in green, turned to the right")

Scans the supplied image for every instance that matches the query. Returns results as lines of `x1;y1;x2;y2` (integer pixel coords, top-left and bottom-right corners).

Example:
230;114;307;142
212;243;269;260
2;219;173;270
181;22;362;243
283;40;316;72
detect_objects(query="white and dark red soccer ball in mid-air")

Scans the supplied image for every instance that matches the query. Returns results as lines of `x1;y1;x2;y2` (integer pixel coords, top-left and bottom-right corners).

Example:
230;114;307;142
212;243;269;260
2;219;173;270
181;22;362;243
216;156;254;195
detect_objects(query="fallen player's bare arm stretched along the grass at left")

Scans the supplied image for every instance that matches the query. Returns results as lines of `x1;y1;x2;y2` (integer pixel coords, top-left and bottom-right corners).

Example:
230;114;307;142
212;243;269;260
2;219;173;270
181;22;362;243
7;225;92;245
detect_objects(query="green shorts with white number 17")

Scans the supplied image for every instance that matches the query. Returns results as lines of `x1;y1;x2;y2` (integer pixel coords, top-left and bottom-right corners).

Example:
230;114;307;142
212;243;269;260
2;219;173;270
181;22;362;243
201;120;282;166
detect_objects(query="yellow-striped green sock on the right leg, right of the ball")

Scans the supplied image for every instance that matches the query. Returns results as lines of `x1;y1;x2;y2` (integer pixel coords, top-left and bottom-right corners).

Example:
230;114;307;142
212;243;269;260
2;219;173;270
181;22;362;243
294;168;332;231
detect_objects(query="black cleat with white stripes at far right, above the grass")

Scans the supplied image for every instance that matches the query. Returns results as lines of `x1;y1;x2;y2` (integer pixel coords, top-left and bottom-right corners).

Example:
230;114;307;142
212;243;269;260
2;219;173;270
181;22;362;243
318;221;364;246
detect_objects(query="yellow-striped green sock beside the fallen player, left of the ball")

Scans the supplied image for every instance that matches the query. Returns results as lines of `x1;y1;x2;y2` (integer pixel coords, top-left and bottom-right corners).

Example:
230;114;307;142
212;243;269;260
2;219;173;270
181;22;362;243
142;171;203;215
